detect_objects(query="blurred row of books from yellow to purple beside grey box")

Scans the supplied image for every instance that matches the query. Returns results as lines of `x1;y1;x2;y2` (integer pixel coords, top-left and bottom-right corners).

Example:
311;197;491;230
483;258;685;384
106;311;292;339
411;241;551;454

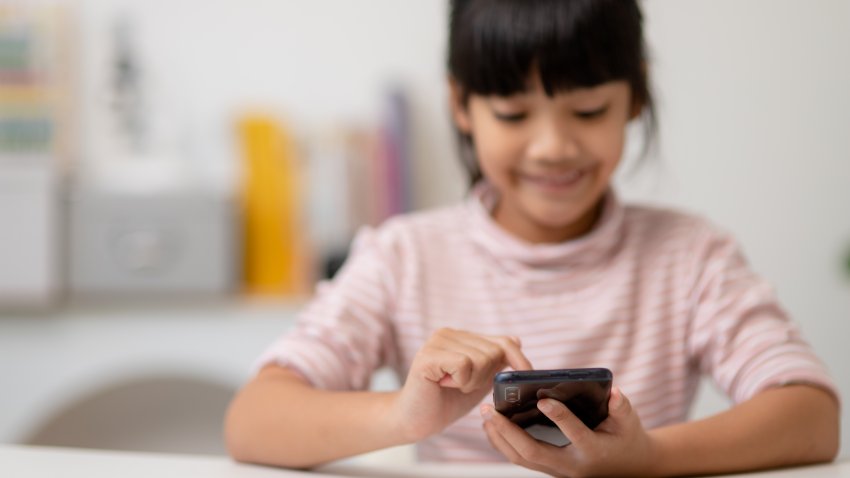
237;88;413;288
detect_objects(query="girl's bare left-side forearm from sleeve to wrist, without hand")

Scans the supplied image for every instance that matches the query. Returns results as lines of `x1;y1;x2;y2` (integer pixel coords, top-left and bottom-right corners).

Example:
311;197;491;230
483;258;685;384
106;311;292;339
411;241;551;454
220;365;407;468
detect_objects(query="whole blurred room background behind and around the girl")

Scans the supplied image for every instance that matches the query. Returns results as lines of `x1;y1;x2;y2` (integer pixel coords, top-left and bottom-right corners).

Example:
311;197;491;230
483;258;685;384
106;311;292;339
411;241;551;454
0;0;850;459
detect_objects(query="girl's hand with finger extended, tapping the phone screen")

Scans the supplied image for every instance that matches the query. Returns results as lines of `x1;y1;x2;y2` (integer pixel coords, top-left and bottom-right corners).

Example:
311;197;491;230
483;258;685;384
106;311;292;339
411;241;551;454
393;329;531;442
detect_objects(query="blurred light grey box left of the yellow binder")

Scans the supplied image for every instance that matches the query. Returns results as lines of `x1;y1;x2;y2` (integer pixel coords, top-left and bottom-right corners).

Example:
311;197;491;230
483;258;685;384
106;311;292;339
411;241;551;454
68;191;241;297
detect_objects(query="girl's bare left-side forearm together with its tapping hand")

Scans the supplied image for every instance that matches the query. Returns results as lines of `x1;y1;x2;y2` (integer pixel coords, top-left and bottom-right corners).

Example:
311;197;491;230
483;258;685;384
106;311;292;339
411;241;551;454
225;329;531;468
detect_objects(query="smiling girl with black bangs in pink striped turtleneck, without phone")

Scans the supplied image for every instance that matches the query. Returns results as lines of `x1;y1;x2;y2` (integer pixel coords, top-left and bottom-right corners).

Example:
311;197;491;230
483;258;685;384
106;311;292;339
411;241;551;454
226;0;838;476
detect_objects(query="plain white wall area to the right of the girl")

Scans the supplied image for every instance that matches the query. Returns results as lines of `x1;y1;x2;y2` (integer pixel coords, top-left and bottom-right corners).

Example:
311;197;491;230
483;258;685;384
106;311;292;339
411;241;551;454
625;0;850;455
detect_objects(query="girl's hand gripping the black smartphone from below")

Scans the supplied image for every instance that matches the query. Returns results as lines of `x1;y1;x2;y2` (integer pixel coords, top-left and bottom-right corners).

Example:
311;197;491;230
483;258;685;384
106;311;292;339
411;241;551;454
481;388;653;477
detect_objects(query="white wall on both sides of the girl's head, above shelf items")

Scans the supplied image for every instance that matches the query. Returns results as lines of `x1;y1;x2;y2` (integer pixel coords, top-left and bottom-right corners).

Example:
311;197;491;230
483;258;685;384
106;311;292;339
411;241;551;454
69;0;850;455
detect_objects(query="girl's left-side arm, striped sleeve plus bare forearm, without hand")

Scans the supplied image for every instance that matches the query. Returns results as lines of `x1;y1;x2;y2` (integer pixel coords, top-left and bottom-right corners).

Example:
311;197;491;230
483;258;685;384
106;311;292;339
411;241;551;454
224;227;409;468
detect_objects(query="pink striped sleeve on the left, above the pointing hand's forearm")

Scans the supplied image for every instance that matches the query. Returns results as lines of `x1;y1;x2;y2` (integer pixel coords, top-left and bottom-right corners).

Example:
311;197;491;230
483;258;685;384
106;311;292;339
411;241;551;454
255;228;396;390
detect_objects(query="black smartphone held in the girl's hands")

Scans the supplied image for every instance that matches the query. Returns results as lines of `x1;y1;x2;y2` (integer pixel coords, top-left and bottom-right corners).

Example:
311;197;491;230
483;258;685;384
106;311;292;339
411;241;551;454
493;368;613;446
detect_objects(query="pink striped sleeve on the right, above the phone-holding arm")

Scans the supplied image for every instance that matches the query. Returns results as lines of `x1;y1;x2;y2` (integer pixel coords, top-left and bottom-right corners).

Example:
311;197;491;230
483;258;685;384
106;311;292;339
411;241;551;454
688;228;838;403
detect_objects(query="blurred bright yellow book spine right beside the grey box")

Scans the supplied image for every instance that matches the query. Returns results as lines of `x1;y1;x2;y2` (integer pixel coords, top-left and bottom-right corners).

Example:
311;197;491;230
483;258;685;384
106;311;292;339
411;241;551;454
238;114;312;296
